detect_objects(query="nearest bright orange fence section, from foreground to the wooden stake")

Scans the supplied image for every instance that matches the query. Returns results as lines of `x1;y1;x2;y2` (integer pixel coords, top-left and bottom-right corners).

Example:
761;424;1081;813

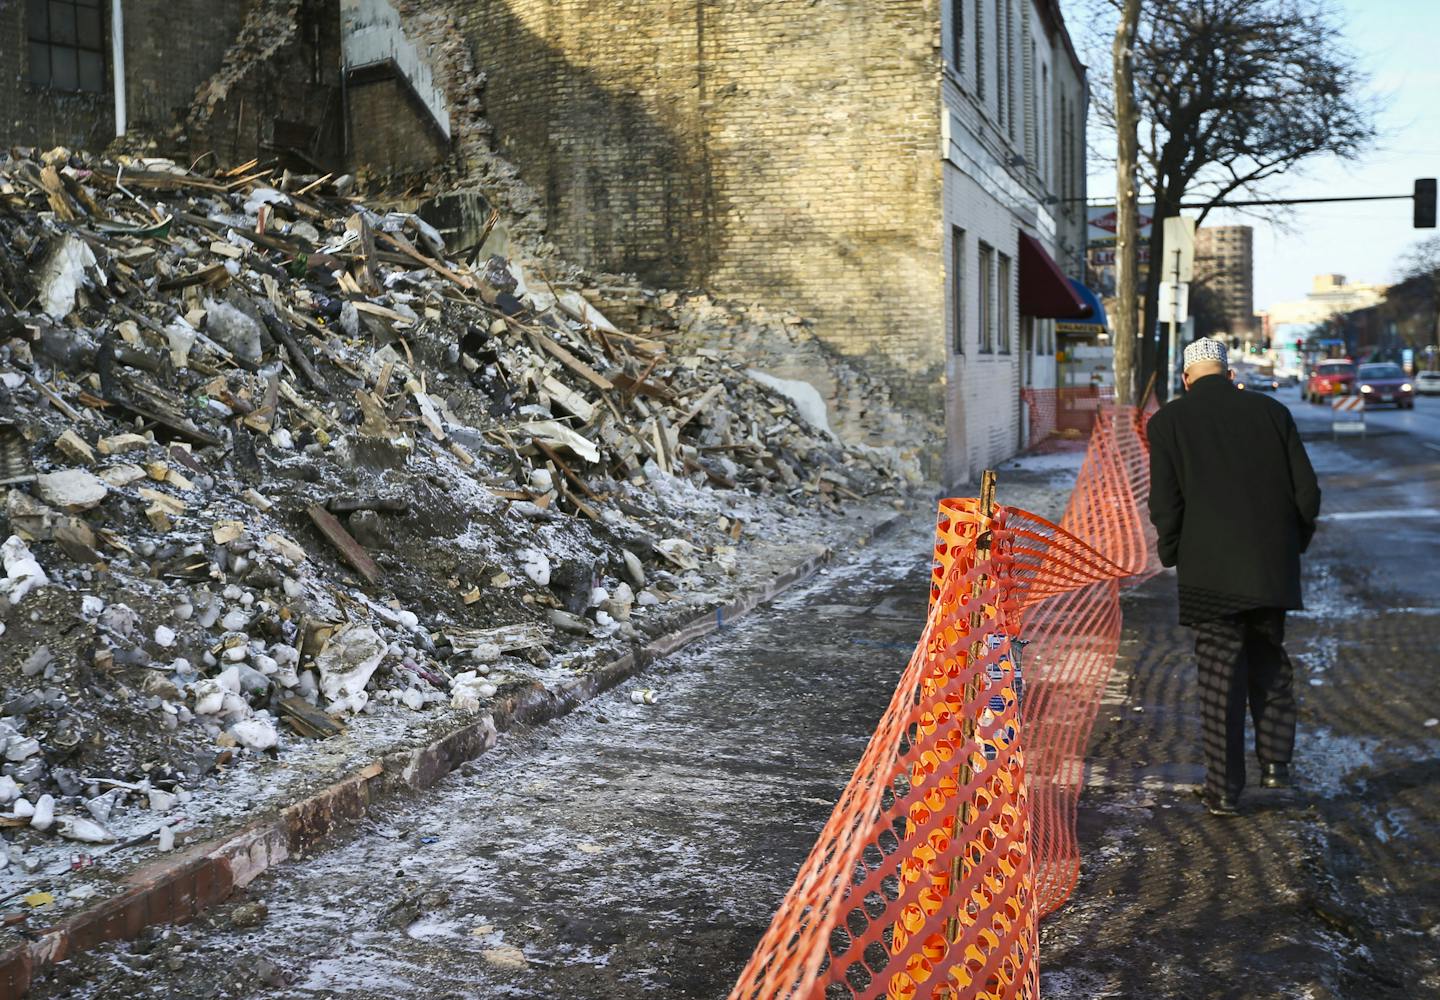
733;500;1037;1000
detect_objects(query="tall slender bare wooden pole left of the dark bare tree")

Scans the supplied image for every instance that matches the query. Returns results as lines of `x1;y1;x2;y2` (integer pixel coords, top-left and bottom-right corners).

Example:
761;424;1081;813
1110;0;1140;406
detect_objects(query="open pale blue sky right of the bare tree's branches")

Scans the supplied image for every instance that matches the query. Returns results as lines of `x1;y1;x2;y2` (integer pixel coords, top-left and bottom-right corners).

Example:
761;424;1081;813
1066;0;1440;311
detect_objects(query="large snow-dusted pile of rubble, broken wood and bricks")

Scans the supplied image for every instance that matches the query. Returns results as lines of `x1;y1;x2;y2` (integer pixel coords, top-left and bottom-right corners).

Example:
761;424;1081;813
0;150;903;867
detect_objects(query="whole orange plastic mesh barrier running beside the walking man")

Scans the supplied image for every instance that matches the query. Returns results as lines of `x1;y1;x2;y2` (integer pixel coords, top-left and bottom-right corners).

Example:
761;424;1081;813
732;406;1153;1000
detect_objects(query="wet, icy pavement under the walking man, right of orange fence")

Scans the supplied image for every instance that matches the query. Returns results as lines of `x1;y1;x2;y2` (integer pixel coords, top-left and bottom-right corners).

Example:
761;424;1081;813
1041;435;1440;1000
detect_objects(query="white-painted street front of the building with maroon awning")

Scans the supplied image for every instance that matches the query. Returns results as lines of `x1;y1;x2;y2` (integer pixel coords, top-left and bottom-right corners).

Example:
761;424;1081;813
942;0;1089;484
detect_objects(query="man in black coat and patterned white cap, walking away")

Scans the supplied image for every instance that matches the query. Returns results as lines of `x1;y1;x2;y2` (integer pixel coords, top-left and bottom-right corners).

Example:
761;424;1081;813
1148;339;1320;816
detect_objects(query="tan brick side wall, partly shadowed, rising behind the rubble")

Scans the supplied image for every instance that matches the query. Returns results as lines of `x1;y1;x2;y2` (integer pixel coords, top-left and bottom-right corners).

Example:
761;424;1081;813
400;0;945;461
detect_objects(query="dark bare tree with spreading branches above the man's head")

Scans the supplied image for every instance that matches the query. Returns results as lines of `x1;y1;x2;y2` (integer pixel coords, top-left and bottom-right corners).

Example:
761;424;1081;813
1097;0;1375;400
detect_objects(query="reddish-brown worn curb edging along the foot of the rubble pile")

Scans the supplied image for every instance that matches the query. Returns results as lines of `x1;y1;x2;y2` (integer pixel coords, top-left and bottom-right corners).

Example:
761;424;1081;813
0;513;904;1000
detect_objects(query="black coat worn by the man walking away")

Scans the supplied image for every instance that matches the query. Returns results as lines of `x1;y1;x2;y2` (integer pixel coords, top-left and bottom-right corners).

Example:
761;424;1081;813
1148;375;1320;624
